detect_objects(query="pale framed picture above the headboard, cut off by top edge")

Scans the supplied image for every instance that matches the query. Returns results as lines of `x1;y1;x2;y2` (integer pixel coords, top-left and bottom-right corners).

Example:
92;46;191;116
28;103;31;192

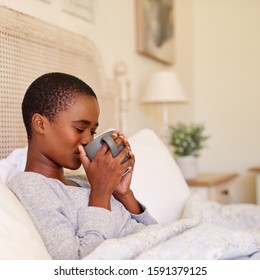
63;0;94;21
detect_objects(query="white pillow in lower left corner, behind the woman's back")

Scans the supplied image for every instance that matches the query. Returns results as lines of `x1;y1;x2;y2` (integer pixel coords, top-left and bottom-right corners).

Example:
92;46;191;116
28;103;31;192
0;182;51;260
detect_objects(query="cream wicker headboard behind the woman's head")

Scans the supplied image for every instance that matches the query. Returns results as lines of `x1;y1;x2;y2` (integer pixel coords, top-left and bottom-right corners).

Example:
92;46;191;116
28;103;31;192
0;7;119;158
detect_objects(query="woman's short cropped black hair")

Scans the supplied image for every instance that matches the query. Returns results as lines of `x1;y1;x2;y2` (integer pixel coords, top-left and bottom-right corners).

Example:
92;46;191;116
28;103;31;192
22;72;97;140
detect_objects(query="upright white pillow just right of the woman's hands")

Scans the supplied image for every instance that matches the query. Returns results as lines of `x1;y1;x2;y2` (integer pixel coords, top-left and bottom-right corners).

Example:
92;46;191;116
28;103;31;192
129;129;190;223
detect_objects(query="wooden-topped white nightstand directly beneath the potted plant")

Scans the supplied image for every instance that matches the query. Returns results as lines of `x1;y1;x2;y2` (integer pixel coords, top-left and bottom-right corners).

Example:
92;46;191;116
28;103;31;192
186;173;238;204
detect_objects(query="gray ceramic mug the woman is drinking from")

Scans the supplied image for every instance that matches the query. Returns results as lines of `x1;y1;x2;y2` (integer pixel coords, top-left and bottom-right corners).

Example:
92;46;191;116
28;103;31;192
84;130;131;175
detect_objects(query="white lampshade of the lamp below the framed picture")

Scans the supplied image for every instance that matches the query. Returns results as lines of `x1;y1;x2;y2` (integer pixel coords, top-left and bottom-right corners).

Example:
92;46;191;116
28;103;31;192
142;70;187;103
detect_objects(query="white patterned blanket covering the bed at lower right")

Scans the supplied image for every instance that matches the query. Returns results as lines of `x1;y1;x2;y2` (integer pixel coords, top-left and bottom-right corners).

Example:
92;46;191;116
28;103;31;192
85;195;260;260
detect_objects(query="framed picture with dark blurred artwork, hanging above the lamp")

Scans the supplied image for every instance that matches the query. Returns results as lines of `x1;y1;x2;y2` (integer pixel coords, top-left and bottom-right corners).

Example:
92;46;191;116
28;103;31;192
135;0;174;64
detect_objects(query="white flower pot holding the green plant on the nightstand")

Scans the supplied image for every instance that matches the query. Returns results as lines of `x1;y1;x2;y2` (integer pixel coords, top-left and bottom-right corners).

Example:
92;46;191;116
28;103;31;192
176;156;198;179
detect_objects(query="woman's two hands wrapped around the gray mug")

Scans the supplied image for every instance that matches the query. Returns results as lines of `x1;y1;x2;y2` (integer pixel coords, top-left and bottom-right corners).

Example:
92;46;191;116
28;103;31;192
79;132;134;209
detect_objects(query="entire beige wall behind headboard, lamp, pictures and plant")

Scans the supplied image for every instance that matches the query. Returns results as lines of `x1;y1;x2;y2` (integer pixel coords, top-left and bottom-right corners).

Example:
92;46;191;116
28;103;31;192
0;0;260;202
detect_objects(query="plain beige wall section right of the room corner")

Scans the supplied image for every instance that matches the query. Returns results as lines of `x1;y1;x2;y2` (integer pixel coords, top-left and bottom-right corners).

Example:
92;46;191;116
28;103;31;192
193;0;260;201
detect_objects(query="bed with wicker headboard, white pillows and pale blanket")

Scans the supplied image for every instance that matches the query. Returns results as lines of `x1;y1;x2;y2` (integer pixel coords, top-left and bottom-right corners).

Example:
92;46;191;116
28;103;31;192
0;7;260;260
